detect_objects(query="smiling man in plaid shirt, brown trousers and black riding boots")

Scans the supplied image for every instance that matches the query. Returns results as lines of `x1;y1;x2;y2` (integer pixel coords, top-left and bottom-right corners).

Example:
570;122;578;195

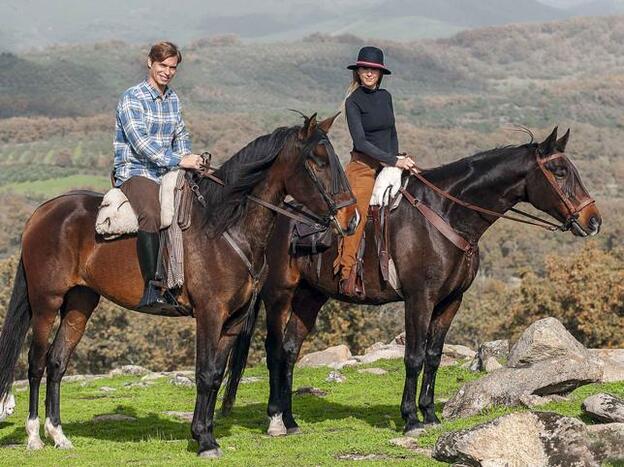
114;42;202;309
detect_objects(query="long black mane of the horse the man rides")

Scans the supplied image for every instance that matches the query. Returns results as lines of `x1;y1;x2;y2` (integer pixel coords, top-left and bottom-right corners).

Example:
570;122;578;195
198;126;300;235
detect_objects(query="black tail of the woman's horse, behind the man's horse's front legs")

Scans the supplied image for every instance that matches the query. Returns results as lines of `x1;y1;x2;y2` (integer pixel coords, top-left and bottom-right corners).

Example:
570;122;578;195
221;300;260;416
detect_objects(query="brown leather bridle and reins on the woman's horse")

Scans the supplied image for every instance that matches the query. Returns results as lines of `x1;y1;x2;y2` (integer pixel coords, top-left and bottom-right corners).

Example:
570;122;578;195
400;150;596;232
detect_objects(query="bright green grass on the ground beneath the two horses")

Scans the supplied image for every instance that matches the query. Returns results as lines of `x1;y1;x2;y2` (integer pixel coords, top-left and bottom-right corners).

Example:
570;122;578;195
0;361;624;466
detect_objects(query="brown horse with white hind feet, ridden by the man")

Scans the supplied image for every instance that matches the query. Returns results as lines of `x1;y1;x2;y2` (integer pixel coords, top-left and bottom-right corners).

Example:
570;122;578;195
0;114;351;457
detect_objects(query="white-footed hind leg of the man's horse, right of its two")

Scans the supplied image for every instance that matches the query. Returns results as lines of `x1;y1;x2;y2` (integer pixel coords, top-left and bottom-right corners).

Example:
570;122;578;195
44;287;100;449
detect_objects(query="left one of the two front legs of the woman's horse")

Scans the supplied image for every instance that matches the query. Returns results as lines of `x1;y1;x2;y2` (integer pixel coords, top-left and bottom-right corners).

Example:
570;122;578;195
401;293;433;436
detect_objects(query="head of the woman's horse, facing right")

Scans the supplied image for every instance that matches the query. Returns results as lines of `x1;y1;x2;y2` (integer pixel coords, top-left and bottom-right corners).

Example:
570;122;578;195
526;127;602;237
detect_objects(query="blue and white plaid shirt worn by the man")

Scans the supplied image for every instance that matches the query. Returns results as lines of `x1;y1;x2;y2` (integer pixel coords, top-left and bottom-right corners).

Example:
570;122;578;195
113;80;191;186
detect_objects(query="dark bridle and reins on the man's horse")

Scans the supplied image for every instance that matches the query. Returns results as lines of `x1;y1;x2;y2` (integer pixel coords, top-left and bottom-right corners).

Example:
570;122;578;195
187;130;356;237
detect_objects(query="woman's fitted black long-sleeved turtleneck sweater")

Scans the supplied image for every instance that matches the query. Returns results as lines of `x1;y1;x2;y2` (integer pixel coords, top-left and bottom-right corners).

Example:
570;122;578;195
345;86;399;166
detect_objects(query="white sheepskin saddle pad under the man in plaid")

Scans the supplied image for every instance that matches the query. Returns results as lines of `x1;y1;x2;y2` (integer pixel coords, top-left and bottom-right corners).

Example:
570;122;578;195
95;170;180;240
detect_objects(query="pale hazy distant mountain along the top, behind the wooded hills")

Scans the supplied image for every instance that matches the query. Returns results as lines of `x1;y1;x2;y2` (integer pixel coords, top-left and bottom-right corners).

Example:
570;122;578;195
0;0;624;51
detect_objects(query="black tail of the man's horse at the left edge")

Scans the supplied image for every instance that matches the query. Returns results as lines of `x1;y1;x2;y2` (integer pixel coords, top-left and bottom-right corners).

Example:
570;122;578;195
0;258;32;401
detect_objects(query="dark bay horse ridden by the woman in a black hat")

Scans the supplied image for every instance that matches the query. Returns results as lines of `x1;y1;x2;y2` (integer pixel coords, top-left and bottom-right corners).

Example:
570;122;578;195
224;128;602;435
